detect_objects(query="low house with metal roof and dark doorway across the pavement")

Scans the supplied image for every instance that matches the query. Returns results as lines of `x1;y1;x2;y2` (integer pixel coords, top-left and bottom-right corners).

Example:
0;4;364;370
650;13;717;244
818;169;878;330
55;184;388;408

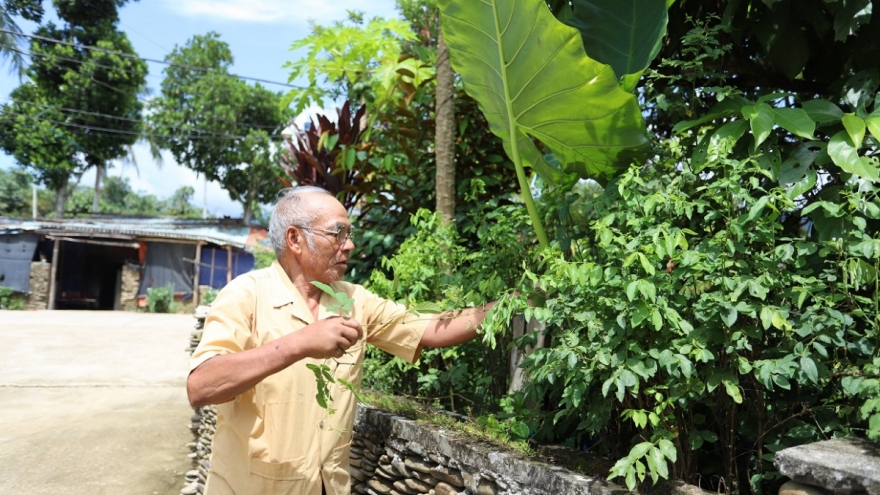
0;218;269;310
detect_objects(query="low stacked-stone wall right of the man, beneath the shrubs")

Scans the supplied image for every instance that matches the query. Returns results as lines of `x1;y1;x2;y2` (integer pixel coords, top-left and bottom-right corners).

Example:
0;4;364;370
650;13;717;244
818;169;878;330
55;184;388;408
351;405;629;495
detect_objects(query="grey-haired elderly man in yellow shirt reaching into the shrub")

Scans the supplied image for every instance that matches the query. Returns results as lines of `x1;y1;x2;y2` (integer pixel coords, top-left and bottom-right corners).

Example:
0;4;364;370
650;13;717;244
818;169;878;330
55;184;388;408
187;187;488;495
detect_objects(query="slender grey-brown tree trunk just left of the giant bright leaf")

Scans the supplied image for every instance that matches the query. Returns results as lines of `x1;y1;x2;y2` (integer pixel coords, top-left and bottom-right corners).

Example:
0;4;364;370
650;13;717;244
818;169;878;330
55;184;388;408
434;34;455;223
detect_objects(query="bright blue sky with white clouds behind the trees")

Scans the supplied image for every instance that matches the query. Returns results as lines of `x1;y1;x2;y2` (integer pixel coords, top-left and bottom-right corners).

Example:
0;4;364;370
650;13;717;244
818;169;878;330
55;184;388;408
0;0;397;217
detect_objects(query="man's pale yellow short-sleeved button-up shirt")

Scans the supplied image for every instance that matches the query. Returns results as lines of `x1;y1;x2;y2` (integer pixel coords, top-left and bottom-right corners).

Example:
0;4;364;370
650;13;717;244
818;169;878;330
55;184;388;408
190;262;428;495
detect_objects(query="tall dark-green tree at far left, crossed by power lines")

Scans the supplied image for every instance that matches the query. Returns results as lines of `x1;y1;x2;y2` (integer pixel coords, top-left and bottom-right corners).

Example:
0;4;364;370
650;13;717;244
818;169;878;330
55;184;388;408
4;0;147;216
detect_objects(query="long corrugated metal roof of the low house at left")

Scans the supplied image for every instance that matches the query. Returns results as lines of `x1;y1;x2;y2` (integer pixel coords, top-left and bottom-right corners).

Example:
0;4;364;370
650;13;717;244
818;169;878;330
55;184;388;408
0;218;262;249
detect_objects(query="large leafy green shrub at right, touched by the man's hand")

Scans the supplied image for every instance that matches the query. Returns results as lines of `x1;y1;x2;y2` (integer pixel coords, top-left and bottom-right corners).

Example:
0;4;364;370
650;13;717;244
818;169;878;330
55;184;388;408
484;129;880;493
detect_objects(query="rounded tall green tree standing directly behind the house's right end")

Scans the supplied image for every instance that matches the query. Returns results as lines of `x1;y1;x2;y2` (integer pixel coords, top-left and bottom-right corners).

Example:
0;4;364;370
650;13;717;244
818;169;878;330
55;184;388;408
150;33;289;227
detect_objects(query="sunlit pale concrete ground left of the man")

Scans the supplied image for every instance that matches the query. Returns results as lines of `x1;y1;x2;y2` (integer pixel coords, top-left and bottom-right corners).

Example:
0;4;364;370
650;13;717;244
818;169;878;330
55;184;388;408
0;311;195;495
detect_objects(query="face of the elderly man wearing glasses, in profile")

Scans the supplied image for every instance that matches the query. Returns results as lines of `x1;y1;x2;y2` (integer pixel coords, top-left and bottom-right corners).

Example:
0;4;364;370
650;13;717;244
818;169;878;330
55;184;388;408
298;194;354;284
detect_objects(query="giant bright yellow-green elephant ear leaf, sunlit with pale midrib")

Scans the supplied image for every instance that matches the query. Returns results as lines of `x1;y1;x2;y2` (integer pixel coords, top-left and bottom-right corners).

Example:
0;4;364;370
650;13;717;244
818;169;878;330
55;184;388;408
439;0;648;185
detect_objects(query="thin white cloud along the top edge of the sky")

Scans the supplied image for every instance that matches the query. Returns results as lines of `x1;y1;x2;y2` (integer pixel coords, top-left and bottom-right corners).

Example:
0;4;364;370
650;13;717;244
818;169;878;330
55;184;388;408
165;0;396;24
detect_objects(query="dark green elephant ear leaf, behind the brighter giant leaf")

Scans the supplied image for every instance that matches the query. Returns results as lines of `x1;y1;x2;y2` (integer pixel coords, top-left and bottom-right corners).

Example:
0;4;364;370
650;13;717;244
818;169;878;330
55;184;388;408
559;0;668;81
